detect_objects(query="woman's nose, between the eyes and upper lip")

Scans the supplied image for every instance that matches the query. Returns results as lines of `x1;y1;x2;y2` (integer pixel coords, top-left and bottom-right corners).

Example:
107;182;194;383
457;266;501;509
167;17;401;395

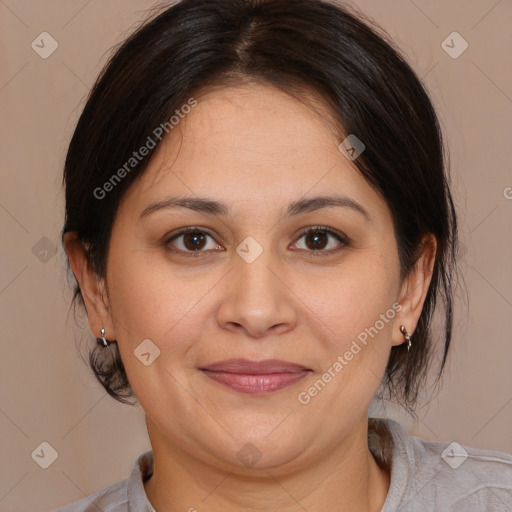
217;245;297;338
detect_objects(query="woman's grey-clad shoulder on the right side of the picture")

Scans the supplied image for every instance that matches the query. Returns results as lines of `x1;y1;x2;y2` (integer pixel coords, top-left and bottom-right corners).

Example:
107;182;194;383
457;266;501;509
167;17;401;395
372;420;512;512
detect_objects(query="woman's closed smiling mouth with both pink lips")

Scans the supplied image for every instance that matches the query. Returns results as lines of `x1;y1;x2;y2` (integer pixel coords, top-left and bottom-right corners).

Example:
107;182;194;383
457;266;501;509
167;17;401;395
200;359;312;394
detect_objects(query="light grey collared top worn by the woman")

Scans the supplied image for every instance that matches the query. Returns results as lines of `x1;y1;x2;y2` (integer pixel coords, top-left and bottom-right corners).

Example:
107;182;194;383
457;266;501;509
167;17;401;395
55;418;512;512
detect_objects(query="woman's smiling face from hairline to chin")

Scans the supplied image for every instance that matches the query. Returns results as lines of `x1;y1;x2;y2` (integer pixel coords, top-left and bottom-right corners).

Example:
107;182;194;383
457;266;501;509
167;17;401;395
81;85;432;468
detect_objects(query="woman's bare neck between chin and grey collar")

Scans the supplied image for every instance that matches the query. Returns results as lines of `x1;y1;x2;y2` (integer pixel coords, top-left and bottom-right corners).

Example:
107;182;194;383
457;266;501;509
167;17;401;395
144;418;390;512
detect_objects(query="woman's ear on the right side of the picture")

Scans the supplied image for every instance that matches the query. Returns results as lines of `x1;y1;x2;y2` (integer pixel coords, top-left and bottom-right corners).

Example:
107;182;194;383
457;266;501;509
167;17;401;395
392;233;437;345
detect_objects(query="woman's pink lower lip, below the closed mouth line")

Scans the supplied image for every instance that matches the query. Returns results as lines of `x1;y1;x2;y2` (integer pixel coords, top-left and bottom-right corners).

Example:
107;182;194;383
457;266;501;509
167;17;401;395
202;370;311;395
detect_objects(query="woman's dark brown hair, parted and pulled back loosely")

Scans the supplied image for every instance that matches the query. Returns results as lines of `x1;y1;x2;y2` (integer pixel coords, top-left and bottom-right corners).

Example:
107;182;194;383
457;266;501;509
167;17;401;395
62;0;457;415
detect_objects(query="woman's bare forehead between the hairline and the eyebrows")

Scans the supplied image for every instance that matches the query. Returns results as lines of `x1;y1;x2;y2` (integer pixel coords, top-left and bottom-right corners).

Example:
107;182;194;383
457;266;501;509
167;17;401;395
119;84;384;222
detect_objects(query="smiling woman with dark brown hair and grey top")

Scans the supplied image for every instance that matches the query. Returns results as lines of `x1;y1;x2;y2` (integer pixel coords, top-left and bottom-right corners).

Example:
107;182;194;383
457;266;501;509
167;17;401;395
54;0;512;512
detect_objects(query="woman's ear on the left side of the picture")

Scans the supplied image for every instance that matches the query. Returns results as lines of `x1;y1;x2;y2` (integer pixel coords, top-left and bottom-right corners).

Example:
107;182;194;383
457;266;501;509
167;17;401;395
64;232;116;340
